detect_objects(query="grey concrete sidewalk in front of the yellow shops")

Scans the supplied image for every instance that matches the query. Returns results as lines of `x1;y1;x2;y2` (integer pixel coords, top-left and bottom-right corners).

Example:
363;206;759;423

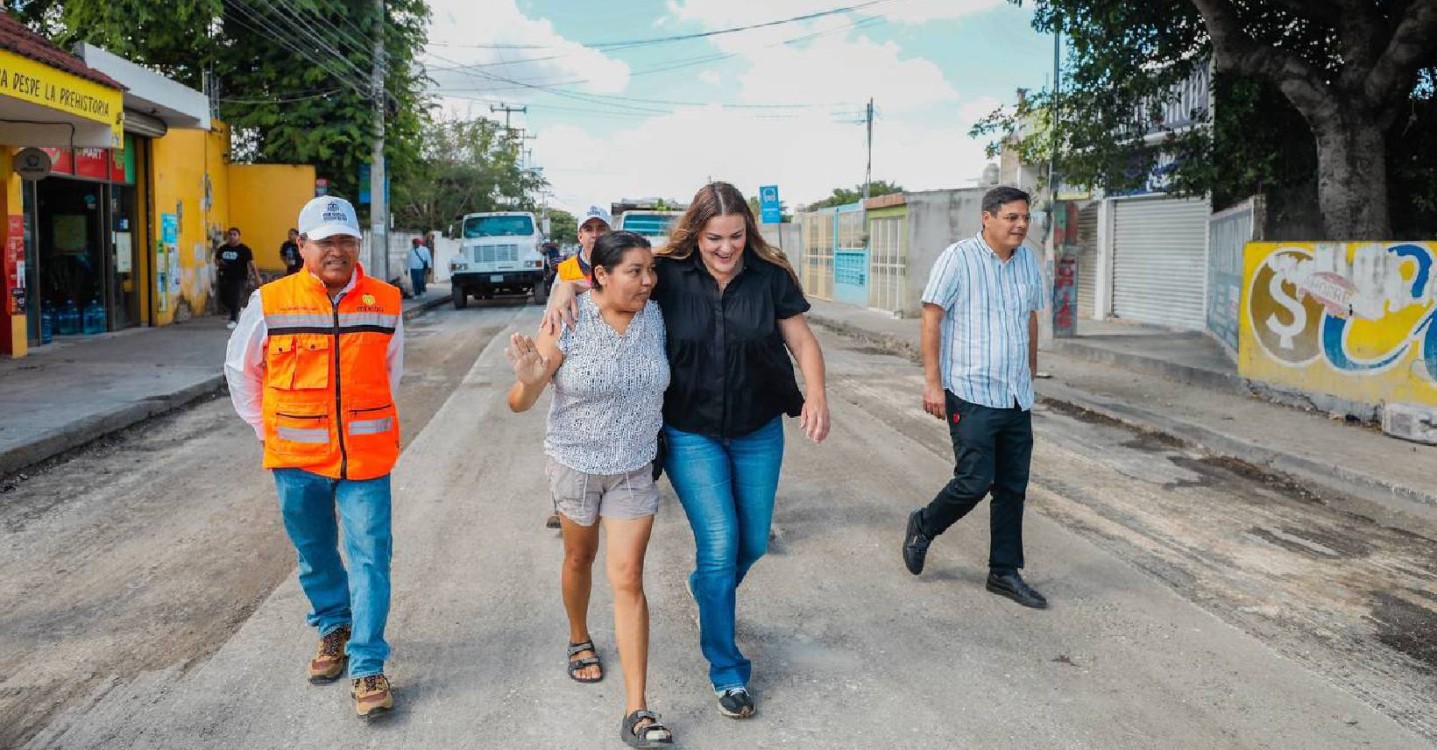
0;277;450;477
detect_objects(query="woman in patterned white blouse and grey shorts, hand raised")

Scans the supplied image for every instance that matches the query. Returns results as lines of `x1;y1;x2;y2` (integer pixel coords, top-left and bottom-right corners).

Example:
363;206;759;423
506;231;673;747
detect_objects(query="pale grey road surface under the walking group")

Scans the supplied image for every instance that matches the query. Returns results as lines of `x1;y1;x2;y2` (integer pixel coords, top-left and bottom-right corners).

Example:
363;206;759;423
19;309;1434;749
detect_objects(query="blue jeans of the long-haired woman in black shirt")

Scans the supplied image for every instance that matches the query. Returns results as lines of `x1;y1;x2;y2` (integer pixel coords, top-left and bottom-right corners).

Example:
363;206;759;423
664;418;783;693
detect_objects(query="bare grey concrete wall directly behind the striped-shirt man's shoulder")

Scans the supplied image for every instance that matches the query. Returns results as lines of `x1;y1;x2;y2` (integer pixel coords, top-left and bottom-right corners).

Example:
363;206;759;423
902;188;987;316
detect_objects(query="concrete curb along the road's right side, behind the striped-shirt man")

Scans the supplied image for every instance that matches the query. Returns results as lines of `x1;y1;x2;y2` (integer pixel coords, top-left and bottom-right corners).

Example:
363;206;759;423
809;313;1437;509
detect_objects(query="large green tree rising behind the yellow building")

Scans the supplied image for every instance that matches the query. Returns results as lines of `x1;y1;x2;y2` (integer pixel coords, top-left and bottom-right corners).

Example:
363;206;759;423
6;0;430;214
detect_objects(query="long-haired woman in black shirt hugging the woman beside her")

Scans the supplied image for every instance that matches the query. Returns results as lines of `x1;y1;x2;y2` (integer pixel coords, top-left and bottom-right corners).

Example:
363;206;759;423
545;182;829;718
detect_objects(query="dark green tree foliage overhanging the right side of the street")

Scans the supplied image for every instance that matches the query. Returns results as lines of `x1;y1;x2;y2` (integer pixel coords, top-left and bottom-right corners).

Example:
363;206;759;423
971;0;1437;231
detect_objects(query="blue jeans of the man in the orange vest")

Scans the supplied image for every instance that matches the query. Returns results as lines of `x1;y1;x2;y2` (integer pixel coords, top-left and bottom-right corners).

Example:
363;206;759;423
274;468;394;680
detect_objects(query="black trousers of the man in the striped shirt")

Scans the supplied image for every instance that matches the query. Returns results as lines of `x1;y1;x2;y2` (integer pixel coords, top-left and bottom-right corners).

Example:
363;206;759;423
923;391;1033;572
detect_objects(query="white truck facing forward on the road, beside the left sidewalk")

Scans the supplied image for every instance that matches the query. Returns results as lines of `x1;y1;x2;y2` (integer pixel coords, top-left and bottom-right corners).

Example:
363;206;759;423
450;211;549;309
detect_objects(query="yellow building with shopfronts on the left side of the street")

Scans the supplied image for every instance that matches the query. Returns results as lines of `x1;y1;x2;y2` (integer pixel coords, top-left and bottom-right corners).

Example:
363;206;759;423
0;29;315;356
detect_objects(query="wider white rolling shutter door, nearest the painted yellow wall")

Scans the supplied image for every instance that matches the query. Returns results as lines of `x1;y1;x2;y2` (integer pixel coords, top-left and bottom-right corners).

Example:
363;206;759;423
1112;198;1211;330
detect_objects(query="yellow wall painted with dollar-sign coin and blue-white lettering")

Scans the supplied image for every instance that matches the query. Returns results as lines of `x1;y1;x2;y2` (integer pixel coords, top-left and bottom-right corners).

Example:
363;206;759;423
1239;241;1437;405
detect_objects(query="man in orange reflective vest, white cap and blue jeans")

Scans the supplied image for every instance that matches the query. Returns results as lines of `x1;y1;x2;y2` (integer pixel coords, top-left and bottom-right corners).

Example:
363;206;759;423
224;197;404;718
